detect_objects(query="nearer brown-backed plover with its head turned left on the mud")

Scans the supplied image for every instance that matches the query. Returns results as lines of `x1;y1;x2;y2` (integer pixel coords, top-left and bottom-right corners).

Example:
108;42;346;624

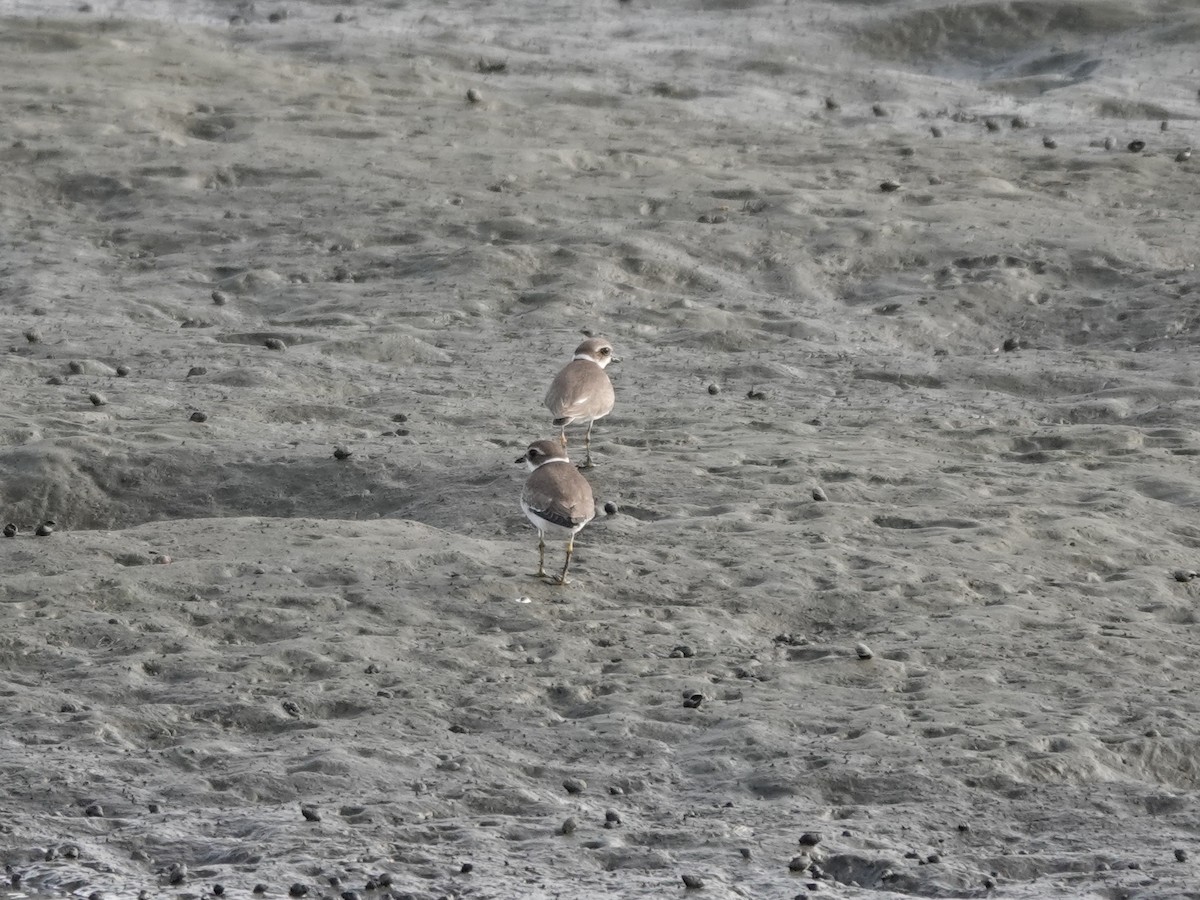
517;439;596;584
